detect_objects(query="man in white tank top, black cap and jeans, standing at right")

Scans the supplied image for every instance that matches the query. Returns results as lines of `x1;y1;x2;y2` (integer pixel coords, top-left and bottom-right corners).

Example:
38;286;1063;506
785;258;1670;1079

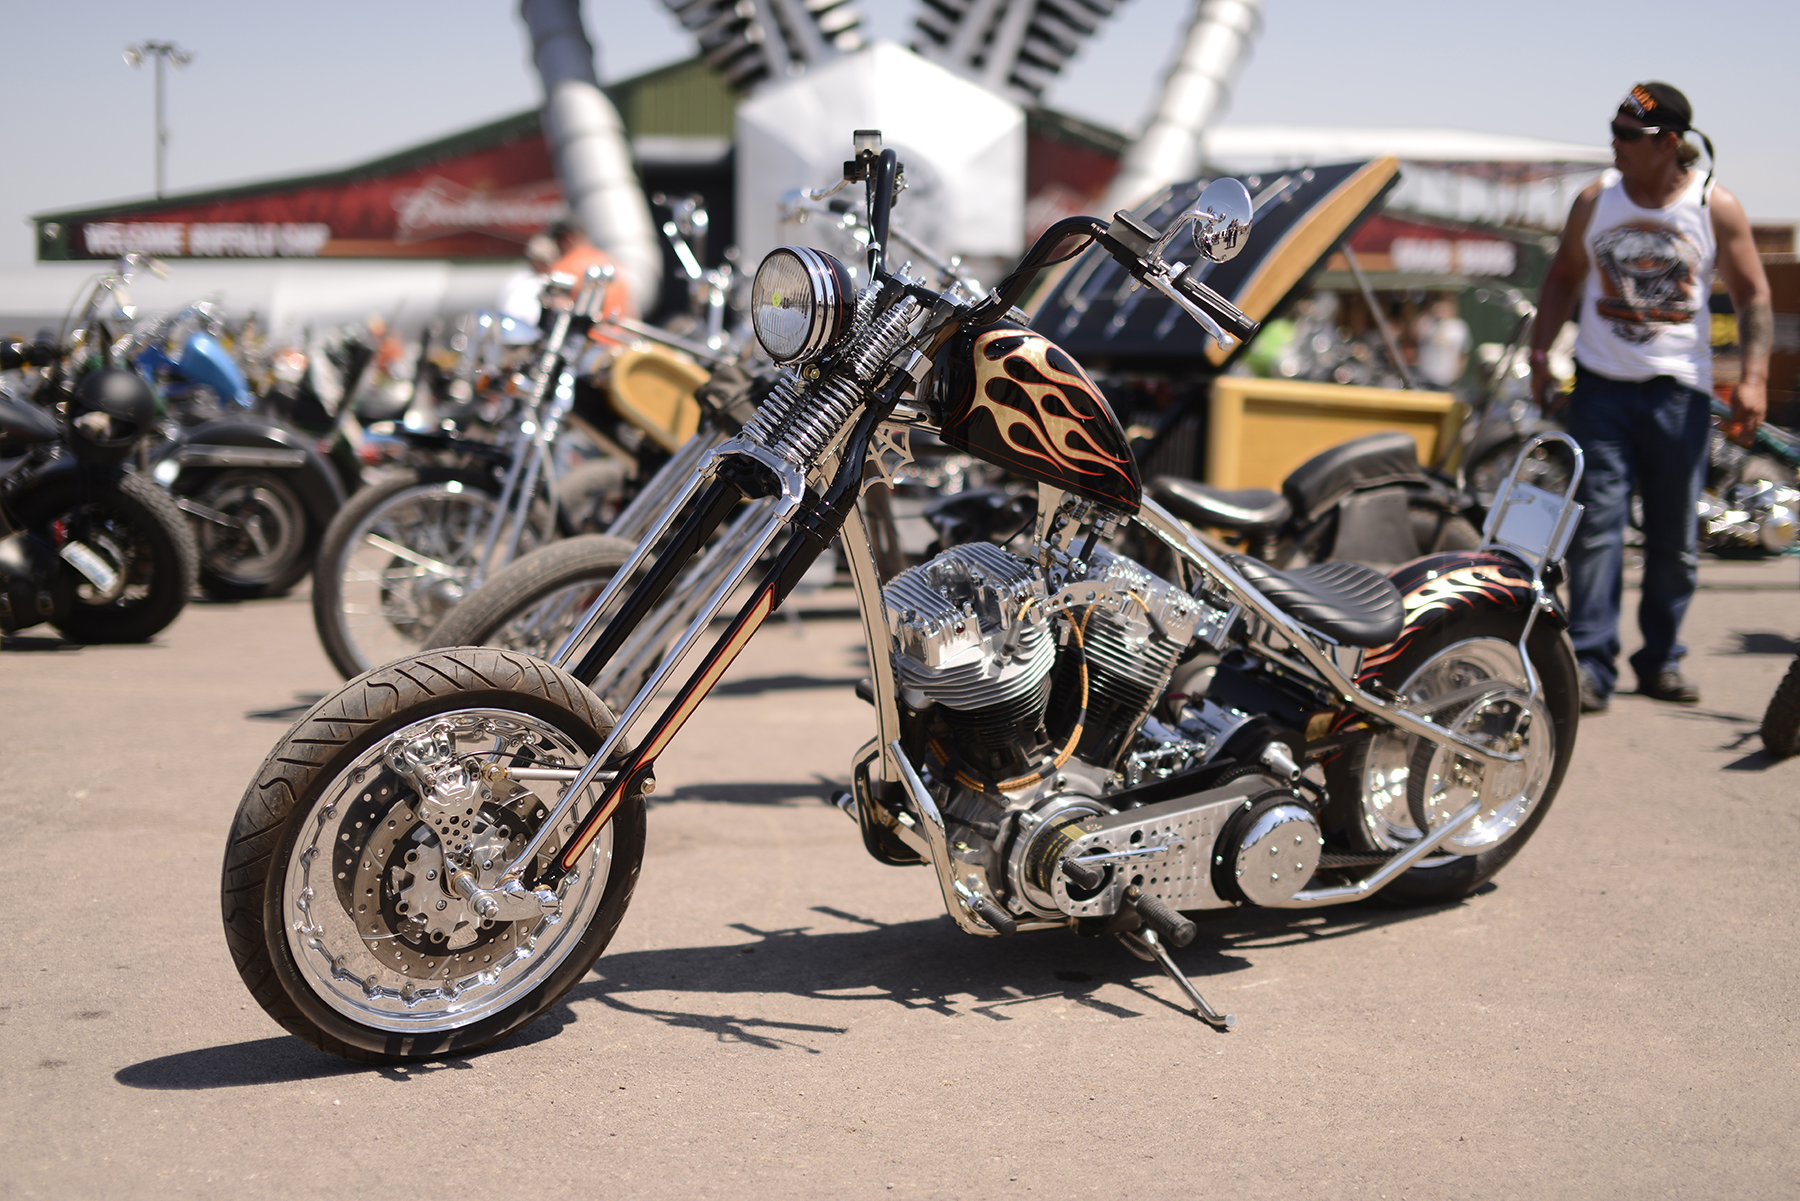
1532;83;1773;713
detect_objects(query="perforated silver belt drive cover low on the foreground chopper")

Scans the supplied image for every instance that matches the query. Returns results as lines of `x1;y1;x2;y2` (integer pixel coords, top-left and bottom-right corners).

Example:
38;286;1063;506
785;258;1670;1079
1051;776;1283;917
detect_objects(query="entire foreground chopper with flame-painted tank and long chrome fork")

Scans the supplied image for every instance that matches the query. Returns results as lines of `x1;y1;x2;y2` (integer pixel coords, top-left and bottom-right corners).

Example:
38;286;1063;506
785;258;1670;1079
221;131;1580;1061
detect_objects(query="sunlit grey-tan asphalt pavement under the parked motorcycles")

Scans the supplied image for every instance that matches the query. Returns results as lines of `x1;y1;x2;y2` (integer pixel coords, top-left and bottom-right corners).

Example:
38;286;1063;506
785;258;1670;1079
0;560;1800;1201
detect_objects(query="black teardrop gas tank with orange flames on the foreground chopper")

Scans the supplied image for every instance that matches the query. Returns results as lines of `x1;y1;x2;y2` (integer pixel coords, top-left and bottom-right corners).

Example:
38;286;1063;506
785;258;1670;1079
954;326;1141;510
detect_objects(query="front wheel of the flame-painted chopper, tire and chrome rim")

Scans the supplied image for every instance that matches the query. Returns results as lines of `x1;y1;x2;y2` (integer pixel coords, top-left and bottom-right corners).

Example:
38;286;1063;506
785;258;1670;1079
221;646;644;1062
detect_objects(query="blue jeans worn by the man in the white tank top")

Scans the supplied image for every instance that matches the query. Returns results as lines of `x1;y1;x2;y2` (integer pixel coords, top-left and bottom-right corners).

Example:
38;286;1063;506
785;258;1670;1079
1568;369;1712;697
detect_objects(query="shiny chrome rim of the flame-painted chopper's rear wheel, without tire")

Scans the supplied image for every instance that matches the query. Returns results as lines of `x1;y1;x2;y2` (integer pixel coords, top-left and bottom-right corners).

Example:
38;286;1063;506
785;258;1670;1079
1361;637;1557;855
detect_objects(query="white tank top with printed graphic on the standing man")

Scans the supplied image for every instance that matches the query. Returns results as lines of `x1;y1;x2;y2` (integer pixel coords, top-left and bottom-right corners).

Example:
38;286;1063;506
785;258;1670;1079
1575;169;1717;391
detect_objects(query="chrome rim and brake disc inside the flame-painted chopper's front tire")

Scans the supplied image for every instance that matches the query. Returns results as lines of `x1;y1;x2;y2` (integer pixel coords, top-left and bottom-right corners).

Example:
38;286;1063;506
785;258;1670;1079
281;709;612;1034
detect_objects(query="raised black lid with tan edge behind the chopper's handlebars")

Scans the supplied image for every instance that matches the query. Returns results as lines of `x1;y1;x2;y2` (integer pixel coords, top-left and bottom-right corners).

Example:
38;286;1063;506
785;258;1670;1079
1031;158;1400;371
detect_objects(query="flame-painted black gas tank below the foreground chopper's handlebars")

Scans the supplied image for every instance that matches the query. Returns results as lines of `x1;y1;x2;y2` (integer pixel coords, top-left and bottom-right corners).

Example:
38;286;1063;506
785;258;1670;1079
932;321;1143;513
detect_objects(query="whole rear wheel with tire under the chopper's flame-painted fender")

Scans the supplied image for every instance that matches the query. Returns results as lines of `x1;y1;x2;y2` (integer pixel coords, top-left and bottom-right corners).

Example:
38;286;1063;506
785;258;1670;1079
1327;612;1580;904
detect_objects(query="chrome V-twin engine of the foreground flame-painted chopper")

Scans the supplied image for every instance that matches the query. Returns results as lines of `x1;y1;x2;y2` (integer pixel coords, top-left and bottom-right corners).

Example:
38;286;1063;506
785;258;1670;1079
882;542;1318;922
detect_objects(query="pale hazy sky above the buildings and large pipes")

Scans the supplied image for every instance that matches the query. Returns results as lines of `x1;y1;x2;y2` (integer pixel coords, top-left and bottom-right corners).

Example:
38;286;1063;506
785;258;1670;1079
0;0;1800;266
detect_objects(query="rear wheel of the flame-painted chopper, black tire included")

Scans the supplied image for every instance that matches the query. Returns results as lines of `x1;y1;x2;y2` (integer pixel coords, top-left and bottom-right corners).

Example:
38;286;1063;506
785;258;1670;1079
1325;612;1580;904
